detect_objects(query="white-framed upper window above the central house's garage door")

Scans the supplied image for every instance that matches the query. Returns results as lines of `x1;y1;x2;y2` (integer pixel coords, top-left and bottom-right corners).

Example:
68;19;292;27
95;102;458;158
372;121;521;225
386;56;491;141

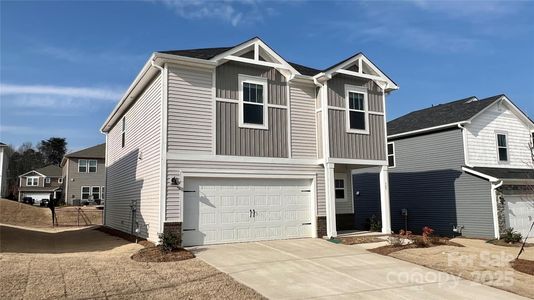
239;75;268;129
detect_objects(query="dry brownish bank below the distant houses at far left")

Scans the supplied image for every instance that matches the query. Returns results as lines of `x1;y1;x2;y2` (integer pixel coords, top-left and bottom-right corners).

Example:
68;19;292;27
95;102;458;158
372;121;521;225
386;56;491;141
0;199;102;227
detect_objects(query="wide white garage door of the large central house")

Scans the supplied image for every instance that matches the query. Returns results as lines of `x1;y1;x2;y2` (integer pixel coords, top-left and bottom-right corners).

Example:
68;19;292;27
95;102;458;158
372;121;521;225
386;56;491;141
182;178;312;246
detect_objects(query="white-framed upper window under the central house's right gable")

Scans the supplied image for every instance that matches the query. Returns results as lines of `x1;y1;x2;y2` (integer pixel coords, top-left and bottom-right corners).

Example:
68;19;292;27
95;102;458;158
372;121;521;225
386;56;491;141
345;85;369;134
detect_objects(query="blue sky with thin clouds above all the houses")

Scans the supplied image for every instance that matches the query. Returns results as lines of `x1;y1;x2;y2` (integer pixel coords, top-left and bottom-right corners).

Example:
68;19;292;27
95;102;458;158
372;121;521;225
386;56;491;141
0;0;534;150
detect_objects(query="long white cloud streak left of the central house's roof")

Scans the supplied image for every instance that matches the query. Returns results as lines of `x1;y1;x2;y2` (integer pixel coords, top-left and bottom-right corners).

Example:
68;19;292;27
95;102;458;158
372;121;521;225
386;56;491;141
0;83;123;101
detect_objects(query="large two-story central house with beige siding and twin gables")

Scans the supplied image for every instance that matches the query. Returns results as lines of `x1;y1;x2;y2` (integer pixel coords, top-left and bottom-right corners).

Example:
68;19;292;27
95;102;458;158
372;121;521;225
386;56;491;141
101;38;398;245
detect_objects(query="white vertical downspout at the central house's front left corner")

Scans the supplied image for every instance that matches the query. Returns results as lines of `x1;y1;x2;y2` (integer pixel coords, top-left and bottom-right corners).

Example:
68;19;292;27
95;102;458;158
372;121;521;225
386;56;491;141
150;57;167;238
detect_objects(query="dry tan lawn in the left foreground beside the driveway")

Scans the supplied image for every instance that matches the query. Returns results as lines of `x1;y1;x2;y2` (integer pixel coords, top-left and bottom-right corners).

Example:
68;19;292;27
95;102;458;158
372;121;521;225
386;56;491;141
0;225;262;299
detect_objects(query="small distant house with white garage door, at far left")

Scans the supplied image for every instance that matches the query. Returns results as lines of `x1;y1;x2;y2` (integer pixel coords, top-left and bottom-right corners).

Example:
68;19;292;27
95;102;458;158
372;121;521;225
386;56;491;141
19;165;63;202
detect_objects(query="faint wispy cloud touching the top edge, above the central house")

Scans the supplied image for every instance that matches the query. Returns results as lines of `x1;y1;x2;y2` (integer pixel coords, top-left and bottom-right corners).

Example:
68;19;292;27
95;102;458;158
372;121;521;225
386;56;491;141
155;0;266;26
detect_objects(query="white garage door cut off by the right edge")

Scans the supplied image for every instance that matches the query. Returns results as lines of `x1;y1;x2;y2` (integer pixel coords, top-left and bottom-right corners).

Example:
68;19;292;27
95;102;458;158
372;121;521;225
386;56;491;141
505;196;534;238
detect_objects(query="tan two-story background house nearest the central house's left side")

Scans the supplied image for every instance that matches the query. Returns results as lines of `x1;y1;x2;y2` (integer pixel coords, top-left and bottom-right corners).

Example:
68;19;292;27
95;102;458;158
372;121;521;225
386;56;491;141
60;144;106;205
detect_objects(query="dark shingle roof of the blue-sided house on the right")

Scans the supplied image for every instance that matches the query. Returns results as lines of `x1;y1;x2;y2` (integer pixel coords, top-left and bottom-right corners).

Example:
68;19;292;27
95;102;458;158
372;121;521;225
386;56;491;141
388;95;504;135
